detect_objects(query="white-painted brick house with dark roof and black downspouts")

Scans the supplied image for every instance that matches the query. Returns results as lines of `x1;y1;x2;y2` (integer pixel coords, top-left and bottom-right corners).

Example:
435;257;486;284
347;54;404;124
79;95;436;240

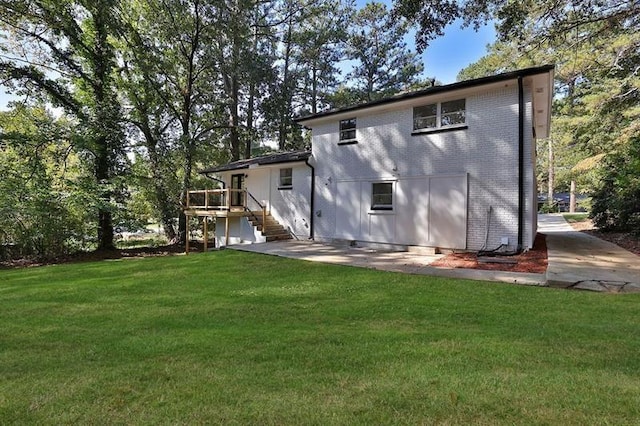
192;65;554;250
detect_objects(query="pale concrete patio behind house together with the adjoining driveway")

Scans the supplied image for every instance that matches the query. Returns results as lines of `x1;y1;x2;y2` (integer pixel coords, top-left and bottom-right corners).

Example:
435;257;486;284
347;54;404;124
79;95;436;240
229;214;640;293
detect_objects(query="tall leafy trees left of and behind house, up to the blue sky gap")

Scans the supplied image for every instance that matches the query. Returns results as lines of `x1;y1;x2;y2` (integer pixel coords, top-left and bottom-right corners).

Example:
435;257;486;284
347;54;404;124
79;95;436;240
0;0;430;256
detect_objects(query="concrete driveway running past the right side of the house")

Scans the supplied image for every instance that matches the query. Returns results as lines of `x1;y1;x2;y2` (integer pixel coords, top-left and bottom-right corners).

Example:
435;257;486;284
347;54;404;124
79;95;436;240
538;214;640;293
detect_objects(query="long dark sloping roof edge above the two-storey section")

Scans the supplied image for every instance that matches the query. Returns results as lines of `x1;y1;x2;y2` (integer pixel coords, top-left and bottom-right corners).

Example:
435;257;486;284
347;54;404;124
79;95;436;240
294;65;555;123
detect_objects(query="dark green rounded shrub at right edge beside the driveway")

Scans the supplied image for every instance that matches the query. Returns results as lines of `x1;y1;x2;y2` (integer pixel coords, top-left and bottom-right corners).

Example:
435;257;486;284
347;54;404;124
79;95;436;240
591;137;640;234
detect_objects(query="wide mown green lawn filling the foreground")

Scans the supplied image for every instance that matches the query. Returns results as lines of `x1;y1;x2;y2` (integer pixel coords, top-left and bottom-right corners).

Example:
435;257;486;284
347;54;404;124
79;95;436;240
0;250;640;425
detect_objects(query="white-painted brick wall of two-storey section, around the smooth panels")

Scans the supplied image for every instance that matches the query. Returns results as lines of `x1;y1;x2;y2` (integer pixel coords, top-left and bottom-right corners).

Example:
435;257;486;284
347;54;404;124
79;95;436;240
312;85;536;250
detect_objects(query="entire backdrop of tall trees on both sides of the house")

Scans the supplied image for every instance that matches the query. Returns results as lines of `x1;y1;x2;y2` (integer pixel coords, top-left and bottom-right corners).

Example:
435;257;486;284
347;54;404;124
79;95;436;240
0;0;640;257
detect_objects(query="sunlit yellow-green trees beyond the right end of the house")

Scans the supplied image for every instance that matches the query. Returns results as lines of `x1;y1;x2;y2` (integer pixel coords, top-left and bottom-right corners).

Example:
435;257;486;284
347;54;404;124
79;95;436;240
459;0;640;223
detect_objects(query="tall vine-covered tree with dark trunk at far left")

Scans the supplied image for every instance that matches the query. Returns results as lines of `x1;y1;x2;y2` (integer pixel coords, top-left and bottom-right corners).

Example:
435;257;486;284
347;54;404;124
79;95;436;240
0;0;126;249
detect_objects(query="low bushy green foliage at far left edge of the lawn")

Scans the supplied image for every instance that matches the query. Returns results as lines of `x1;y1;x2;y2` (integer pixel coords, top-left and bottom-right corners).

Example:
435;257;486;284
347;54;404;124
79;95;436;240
0;105;96;259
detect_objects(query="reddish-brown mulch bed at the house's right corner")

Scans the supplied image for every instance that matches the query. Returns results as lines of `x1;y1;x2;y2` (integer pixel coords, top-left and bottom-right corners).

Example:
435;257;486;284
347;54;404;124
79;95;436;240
430;234;547;274
